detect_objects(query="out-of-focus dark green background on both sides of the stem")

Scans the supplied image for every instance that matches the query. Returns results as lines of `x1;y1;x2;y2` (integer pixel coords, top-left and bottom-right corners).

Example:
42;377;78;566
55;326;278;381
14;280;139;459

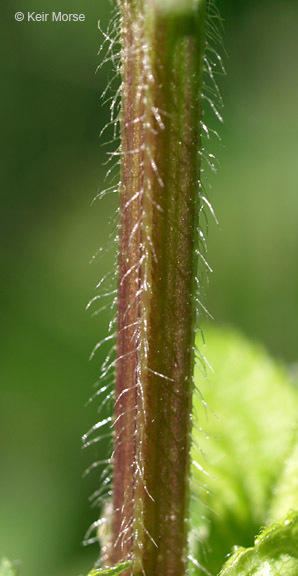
0;0;298;576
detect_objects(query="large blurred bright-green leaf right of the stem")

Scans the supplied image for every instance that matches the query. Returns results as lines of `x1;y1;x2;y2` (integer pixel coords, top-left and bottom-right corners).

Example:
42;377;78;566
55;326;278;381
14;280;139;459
191;329;298;574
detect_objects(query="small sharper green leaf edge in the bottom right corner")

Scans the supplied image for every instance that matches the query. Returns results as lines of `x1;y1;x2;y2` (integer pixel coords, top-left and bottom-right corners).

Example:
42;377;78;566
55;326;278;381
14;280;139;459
220;514;298;576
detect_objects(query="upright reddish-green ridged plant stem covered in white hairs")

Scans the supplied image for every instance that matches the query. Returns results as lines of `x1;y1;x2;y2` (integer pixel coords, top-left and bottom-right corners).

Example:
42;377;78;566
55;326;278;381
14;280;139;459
111;0;205;576
